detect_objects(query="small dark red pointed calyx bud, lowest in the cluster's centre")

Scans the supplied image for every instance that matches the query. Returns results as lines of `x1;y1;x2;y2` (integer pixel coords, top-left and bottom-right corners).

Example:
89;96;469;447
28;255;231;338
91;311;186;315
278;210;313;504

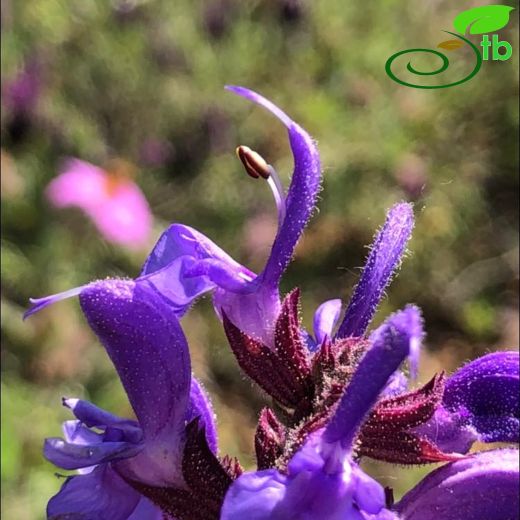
255;408;285;470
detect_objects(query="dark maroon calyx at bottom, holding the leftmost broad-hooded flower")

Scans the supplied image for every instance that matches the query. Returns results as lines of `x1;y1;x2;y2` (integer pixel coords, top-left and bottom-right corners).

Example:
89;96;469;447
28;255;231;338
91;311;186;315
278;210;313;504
129;418;242;520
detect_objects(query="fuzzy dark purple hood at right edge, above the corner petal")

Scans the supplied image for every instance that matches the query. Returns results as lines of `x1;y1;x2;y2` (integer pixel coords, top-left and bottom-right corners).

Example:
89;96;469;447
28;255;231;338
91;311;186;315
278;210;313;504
443;352;520;442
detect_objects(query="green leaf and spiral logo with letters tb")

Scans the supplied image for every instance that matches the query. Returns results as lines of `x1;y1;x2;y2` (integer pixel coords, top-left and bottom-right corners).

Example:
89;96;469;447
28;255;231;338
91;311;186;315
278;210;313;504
385;5;514;89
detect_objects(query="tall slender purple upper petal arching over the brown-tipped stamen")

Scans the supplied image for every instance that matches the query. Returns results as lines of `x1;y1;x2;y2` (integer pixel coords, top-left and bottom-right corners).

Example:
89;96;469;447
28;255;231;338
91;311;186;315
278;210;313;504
226;86;321;290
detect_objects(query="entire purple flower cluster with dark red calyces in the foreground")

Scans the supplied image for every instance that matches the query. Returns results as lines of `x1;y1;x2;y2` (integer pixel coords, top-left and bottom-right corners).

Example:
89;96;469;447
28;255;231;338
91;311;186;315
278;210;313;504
26;87;519;520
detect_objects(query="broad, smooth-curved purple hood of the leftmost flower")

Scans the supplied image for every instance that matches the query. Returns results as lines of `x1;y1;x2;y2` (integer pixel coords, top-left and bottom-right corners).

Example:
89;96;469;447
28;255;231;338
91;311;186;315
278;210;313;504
80;280;191;442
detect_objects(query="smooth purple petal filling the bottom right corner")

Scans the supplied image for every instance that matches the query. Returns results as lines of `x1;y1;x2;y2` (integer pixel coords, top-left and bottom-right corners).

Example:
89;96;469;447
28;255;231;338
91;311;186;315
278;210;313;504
396;449;520;520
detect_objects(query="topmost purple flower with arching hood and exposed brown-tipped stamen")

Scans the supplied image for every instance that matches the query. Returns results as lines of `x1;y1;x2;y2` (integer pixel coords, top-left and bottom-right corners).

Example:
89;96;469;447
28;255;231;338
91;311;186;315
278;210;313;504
137;87;321;345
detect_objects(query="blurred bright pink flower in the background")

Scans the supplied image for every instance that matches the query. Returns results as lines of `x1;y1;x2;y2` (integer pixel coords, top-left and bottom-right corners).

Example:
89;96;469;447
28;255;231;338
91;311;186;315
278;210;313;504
46;159;153;249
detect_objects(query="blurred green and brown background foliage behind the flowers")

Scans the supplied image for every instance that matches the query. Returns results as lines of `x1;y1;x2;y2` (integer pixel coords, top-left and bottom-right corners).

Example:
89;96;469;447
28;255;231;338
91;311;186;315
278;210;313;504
1;0;518;520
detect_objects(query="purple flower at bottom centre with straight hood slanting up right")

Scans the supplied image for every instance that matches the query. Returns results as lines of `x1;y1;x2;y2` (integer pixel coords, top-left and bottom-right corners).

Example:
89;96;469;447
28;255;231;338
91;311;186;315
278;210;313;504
222;307;421;520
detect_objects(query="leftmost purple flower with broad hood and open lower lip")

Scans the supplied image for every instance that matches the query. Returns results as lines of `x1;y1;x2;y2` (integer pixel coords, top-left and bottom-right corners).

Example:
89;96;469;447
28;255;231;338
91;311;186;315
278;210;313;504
44;280;233;520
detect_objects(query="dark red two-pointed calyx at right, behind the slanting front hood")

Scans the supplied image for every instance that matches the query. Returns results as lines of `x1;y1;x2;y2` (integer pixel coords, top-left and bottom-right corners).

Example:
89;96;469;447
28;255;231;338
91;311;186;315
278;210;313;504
356;374;460;464
